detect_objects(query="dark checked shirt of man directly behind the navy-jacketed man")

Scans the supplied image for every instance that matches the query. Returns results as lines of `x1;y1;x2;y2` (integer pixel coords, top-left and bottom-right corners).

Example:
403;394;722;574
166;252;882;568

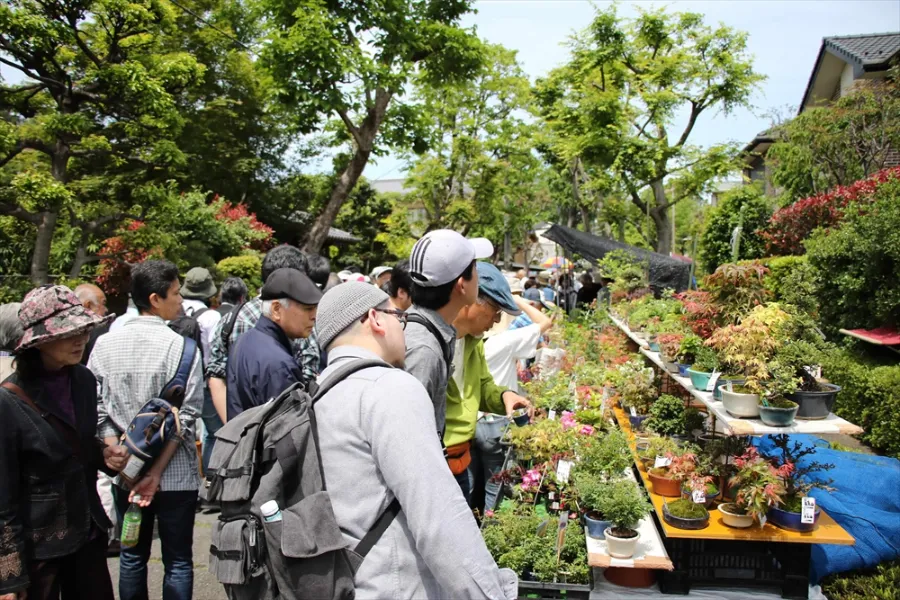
206;297;321;385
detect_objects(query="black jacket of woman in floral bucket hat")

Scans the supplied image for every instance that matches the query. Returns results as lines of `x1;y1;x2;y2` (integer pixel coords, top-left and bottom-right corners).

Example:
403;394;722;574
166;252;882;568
0;365;114;594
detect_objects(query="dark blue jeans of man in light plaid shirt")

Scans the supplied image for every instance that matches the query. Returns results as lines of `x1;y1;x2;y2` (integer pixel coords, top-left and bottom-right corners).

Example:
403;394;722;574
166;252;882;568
114;486;197;600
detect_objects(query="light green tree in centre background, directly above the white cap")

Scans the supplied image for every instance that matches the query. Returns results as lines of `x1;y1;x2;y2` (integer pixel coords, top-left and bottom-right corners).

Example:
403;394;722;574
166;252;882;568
398;45;546;253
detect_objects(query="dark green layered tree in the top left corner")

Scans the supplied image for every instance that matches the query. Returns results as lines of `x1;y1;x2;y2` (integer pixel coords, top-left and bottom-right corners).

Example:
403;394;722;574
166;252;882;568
0;0;204;284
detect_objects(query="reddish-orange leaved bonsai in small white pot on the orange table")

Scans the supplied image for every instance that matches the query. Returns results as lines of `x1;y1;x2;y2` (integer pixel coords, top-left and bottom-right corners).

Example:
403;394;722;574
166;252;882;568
719;446;784;529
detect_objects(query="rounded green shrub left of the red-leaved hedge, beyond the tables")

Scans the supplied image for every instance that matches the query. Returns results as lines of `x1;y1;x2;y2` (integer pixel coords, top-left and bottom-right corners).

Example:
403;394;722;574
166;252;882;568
698;185;772;273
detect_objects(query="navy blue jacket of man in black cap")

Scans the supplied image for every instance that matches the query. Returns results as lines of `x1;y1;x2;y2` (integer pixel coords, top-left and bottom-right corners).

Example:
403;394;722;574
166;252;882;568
226;317;303;421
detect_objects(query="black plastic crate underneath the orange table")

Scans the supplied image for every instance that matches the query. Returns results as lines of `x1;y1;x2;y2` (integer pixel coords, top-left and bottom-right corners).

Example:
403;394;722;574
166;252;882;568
659;538;810;598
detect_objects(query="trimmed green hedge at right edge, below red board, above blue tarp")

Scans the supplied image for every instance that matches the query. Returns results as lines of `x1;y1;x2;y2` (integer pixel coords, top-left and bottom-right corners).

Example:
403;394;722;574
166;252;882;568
821;350;900;458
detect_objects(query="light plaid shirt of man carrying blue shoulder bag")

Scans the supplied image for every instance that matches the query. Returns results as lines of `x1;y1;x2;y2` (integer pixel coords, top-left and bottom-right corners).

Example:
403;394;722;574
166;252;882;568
88;316;203;492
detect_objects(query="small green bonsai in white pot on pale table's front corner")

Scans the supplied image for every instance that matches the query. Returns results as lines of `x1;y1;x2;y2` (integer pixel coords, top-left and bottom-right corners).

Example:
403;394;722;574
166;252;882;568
600;479;650;558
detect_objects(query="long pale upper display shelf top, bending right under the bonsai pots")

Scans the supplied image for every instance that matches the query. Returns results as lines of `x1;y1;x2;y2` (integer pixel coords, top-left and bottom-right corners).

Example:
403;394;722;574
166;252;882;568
610;314;863;435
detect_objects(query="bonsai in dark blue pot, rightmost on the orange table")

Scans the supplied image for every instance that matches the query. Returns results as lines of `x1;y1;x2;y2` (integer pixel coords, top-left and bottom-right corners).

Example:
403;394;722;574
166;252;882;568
764;434;834;532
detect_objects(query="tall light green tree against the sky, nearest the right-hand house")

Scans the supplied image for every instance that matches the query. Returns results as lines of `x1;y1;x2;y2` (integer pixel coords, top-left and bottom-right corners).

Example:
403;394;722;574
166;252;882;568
544;6;764;253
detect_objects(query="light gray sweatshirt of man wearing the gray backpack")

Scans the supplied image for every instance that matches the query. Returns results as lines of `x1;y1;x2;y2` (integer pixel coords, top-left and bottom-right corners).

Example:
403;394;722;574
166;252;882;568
315;346;518;600
